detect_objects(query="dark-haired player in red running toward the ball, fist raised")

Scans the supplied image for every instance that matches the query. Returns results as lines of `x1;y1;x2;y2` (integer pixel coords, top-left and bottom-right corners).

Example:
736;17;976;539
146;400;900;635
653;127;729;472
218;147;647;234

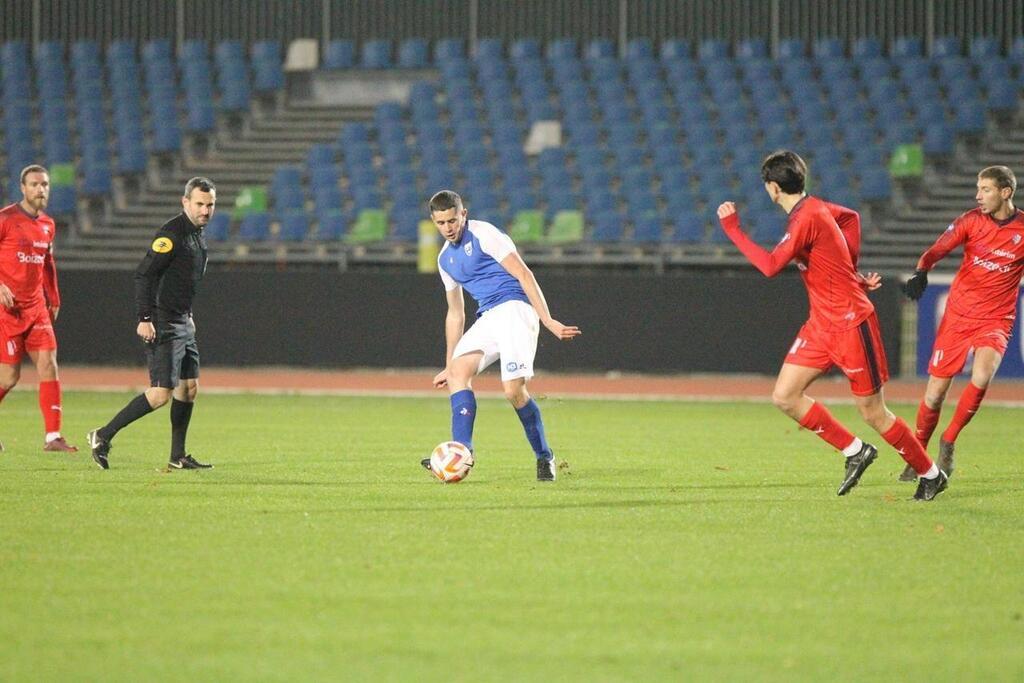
718;151;947;501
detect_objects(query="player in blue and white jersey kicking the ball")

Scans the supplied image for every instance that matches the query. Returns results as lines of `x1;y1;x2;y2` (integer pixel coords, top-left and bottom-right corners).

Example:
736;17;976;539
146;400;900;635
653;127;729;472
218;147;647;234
423;190;580;481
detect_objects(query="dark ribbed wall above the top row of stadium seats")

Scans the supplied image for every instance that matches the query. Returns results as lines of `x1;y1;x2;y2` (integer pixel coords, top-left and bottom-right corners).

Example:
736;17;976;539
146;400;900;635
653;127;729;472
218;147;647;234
0;0;1024;51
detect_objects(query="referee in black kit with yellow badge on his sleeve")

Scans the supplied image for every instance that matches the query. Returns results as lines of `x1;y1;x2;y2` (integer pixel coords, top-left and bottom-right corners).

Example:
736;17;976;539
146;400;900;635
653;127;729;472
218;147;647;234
87;177;217;470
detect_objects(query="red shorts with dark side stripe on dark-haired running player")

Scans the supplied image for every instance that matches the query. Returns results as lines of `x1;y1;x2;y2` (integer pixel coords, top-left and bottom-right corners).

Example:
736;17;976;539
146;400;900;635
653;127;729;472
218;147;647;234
785;313;889;396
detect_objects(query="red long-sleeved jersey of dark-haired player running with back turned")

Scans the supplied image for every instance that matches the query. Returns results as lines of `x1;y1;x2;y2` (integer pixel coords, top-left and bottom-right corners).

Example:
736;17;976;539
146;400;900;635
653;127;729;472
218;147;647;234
722;197;874;332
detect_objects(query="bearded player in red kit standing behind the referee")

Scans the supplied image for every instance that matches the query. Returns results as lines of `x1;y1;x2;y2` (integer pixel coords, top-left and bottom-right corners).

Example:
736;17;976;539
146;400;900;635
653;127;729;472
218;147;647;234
0;166;78;452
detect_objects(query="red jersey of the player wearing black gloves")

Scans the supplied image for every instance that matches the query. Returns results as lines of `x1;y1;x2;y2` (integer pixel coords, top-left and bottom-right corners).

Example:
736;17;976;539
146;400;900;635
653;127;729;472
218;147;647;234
918;209;1024;319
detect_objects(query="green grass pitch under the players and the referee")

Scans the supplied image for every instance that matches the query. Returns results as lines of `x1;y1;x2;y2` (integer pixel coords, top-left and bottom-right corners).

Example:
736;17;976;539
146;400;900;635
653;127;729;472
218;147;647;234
0;391;1024;681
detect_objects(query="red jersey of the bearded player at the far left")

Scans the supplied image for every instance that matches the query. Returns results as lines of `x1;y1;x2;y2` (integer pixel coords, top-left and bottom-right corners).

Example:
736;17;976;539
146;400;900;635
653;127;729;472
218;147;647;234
0;204;60;309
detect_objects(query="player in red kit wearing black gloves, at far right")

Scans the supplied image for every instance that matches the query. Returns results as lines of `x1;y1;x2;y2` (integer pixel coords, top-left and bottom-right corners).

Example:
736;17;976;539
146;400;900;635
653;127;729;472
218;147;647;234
900;166;1024;480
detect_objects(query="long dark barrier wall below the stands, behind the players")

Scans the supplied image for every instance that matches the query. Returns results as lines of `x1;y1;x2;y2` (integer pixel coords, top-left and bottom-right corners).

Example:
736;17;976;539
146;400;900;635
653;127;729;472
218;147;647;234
57;270;900;374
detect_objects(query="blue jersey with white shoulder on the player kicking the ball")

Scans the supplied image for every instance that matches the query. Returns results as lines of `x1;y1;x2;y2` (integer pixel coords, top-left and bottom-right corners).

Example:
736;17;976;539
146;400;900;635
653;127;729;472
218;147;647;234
437;220;529;316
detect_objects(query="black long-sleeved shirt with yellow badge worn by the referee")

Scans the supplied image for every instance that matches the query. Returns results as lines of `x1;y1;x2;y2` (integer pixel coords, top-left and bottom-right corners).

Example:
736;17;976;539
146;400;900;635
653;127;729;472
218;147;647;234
135;213;207;323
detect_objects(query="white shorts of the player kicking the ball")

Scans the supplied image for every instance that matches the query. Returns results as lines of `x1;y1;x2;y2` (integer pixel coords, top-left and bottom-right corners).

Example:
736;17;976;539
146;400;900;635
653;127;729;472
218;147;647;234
452;301;541;382
